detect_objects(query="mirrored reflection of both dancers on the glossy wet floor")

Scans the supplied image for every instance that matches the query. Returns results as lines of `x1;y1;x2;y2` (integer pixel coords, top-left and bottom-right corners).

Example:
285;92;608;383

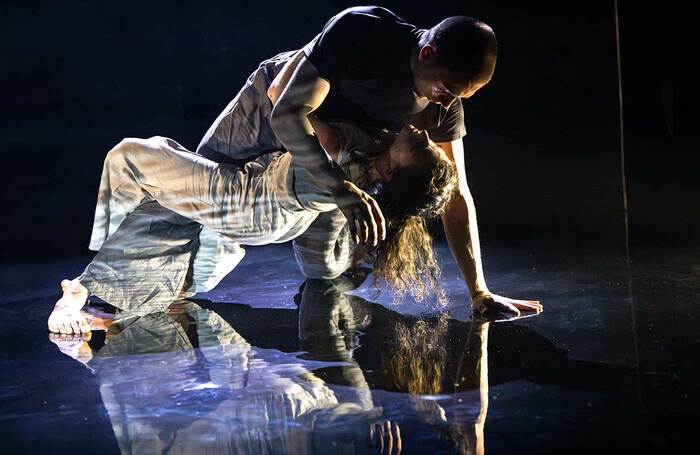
52;292;488;454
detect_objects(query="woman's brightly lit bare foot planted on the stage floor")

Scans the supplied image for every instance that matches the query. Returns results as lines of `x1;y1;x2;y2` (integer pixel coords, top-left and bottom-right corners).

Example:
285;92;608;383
48;279;90;334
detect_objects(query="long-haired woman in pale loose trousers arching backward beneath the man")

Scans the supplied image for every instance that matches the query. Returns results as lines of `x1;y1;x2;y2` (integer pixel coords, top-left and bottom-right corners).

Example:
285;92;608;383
49;119;455;333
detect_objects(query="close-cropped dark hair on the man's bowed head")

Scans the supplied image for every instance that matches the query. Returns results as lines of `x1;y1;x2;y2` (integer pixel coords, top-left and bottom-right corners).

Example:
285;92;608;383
430;16;498;81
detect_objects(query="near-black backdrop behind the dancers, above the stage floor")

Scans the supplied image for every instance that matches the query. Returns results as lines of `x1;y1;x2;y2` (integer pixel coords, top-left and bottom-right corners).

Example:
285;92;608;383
0;0;700;262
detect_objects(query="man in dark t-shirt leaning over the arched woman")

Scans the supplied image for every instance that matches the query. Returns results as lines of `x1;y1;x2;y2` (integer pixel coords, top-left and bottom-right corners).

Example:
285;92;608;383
197;6;541;314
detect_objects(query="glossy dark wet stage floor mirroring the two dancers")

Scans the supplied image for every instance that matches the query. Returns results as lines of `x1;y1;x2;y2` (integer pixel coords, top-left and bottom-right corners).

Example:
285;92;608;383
0;245;700;454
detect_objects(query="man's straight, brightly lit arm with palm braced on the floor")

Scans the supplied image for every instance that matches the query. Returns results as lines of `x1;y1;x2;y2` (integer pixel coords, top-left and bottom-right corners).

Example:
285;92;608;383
438;139;542;314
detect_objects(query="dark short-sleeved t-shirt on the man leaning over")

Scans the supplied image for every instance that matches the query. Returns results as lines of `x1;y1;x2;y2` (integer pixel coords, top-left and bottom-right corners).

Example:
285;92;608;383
304;6;466;142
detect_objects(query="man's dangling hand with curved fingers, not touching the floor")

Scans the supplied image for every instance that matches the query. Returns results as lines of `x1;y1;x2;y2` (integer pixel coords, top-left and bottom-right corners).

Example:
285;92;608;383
335;180;386;246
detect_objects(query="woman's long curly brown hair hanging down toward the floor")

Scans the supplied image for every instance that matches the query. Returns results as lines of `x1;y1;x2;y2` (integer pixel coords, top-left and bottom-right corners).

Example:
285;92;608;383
360;143;458;304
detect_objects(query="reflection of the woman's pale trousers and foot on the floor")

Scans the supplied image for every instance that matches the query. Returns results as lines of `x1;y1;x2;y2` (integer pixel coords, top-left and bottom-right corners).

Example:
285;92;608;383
51;302;400;455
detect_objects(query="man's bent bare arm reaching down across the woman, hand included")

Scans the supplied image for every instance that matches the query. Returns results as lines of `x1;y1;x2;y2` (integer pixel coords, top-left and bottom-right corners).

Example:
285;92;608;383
270;56;386;244
